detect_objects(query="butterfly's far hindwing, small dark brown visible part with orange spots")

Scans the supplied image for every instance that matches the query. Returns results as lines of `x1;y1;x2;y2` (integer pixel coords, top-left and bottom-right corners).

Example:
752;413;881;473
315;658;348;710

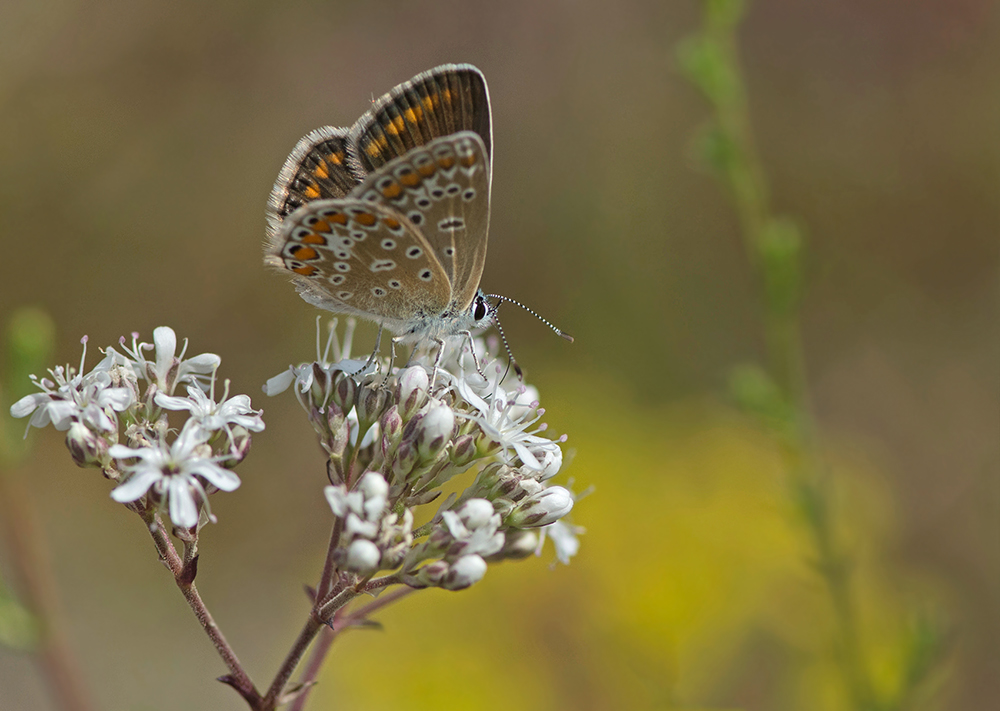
267;126;363;241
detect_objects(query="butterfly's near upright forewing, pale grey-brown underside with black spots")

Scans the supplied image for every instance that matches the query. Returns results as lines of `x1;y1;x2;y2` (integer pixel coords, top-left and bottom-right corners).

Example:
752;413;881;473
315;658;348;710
352;131;490;310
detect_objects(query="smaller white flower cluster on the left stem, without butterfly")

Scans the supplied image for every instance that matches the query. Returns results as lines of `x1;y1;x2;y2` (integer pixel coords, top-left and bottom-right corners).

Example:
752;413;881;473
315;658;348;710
10;327;264;529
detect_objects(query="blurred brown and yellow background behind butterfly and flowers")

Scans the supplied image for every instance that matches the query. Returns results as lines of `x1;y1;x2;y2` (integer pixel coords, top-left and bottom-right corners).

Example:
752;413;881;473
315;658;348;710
0;0;1000;711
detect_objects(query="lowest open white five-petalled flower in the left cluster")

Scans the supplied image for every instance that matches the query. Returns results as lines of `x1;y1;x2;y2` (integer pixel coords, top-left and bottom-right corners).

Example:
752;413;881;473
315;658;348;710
109;420;240;528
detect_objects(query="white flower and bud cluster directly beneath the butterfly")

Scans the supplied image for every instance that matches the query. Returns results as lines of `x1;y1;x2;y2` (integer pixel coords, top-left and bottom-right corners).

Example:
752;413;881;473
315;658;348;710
265;322;579;590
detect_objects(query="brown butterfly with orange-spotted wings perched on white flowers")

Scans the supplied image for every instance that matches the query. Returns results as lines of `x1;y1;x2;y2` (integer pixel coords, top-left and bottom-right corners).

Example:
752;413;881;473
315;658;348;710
265;64;572;368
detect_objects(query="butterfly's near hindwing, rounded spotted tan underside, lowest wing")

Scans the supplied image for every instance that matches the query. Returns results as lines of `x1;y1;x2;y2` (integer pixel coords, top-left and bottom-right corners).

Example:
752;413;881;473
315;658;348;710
268;197;451;330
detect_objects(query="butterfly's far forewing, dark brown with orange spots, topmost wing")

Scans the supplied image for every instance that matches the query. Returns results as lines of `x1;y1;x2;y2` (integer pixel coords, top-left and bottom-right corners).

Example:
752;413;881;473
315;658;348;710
351;64;492;173
